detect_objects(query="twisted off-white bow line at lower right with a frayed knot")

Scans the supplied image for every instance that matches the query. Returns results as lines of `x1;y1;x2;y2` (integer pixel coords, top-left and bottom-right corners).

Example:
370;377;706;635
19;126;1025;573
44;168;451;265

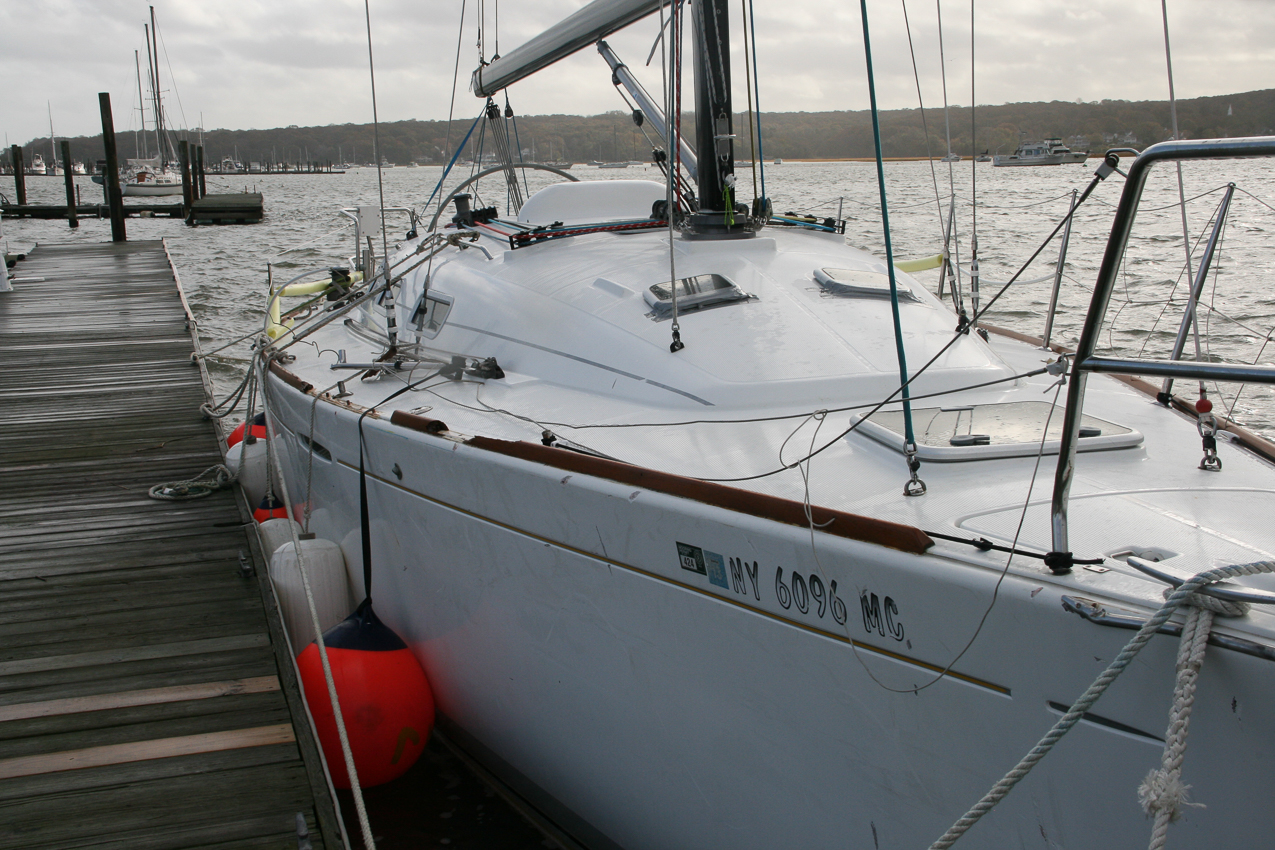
929;561;1275;850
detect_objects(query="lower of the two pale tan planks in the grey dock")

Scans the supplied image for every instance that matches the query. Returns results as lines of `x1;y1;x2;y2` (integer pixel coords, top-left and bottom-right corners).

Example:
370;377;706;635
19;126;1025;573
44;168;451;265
0;723;297;780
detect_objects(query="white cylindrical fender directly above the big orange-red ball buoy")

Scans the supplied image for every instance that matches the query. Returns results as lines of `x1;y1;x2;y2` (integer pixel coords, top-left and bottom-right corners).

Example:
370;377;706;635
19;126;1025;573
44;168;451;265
270;539;354;656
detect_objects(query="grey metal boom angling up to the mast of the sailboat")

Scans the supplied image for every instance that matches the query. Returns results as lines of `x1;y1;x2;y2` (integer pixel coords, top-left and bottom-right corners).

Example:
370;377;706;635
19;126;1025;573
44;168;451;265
473;0;668;97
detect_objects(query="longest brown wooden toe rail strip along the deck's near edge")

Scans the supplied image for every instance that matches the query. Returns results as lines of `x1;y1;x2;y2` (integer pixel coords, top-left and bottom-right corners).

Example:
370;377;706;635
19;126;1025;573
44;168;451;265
465;437;935;554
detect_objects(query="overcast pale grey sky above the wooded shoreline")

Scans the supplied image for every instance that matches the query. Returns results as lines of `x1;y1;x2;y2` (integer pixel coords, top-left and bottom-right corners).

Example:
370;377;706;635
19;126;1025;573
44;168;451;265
0;0;1275;144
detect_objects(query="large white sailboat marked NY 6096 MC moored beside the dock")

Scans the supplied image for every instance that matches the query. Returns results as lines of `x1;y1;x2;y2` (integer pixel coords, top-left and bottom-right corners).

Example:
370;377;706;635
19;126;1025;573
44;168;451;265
255;0;1275;850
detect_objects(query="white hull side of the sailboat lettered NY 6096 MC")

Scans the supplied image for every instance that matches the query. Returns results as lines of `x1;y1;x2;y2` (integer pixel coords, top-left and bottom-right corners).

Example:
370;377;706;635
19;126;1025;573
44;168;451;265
269;377;1275;849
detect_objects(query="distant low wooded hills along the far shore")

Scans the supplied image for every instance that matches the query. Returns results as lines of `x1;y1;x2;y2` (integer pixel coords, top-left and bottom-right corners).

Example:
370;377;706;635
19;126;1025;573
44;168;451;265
12;89;1275;166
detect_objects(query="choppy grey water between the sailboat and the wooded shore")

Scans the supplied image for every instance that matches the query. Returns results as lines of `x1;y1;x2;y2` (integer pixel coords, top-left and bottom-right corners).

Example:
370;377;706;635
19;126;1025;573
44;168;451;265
4;159;1275;437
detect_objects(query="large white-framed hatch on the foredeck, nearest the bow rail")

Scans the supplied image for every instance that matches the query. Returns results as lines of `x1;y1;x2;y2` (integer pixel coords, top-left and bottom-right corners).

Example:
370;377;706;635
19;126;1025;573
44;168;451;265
858;401;1142;461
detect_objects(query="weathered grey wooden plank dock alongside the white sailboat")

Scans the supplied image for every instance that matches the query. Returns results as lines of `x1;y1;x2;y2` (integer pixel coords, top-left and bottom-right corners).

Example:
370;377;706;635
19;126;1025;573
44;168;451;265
0;242;343;850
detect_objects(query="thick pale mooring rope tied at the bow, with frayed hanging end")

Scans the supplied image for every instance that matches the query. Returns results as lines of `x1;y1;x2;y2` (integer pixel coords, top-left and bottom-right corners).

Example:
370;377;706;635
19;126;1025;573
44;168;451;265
929;561;1275;850
